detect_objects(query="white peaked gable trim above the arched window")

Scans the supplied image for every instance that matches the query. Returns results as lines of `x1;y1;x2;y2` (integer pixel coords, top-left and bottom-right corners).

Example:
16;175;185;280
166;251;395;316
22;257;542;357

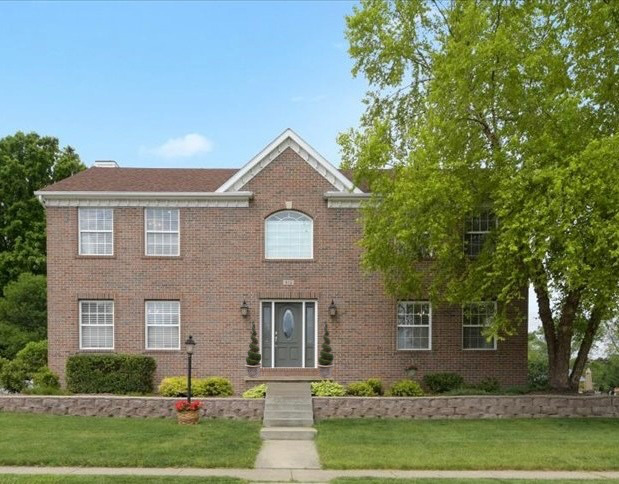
216;128;363;193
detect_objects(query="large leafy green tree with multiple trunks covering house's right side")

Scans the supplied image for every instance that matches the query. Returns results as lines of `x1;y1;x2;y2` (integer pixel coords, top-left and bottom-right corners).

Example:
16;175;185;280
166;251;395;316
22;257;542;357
340;0;619;390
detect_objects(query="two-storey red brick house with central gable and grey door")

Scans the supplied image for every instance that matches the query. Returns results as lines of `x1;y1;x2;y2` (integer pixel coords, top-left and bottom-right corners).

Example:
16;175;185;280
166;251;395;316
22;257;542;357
37;130;527;390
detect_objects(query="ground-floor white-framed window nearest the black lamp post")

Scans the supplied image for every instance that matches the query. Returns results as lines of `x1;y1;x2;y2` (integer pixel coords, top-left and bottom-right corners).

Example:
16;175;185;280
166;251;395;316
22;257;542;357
145;301;181;350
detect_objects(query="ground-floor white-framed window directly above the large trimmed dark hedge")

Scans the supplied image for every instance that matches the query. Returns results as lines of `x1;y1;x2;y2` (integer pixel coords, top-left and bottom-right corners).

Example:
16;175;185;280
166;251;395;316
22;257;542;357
79;300;114;350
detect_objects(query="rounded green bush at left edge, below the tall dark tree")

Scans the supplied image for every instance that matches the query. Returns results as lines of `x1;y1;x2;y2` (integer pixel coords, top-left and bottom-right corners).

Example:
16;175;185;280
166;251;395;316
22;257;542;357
0;273;47;358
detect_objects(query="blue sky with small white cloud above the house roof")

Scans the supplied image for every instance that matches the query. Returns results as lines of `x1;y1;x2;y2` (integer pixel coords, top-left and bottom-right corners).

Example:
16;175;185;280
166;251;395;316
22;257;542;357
0;1;366;167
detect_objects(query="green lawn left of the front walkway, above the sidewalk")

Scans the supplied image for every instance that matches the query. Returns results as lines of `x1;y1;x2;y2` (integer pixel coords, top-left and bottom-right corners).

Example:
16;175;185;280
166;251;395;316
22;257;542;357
0;412;261;468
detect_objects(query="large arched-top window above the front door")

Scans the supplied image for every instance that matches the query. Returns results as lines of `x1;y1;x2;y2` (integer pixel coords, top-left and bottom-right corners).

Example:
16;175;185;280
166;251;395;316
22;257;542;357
264;210;314;259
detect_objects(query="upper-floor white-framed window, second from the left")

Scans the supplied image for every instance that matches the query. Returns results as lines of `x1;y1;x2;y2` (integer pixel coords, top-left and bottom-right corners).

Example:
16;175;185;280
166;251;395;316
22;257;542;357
144;208;180;256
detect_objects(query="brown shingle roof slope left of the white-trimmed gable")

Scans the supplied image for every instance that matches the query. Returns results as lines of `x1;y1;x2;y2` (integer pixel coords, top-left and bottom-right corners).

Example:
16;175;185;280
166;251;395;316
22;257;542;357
41;167;238;192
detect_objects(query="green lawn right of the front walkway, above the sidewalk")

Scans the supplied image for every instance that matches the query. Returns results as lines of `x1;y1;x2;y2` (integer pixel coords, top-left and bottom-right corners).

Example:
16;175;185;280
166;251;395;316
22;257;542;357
317;419;619;470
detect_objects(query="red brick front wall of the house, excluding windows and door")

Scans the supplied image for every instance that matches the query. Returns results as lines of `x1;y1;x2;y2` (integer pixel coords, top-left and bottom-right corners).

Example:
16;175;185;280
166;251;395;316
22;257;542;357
47;149;527;391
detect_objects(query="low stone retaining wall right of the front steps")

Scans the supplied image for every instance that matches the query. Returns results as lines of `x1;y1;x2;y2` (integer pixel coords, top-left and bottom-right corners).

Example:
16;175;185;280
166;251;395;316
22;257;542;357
313;395;619;421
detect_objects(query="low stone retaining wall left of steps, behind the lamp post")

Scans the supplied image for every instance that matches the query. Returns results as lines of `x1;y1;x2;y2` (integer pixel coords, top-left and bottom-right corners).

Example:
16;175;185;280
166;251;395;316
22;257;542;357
0;395;264;420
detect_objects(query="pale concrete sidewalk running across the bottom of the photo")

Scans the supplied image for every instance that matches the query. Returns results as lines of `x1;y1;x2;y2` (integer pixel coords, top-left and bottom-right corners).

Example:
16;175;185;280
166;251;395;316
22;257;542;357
0;467;619;482
